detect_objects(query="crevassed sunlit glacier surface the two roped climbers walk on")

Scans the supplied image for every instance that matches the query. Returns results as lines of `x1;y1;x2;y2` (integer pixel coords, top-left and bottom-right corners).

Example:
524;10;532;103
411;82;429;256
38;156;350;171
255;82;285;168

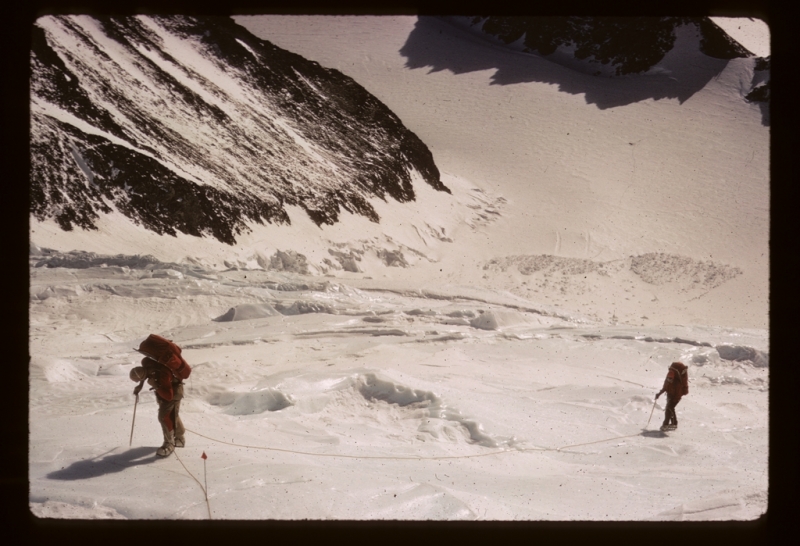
29;260;769;520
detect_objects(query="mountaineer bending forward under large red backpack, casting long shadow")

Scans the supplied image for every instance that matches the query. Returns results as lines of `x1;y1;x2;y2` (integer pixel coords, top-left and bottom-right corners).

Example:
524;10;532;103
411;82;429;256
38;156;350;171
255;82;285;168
130;334;192;457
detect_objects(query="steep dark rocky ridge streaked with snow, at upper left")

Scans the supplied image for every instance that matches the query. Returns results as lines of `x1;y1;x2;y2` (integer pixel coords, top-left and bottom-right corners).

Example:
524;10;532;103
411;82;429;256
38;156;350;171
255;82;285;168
30;16;449;244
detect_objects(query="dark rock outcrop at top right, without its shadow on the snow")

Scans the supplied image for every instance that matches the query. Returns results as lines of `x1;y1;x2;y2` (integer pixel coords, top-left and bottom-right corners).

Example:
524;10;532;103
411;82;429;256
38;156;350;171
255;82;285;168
460;17;752;75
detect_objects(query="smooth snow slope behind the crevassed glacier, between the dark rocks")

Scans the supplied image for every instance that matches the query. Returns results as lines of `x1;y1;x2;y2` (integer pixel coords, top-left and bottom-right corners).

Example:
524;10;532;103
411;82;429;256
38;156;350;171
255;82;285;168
31;16;769;328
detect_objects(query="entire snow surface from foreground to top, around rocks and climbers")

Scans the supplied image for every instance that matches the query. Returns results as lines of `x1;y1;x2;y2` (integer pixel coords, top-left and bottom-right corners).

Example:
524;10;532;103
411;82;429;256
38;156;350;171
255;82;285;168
29;17;769;520
